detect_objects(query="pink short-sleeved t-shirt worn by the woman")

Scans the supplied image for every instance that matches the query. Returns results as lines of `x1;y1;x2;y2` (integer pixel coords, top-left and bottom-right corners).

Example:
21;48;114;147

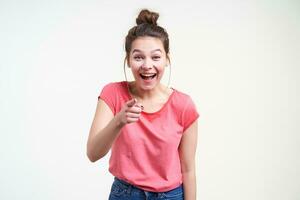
98;81;199;192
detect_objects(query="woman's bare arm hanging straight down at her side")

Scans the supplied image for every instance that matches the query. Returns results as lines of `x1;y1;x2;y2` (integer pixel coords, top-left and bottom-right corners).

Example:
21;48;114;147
178;120;198;200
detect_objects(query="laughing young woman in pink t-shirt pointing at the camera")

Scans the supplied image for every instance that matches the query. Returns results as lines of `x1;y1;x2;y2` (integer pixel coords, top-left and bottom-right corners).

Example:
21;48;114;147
87;9;199;200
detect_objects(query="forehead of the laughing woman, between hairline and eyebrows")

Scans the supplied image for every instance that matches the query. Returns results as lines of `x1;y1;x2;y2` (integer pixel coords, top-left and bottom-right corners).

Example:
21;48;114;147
131;37;165;53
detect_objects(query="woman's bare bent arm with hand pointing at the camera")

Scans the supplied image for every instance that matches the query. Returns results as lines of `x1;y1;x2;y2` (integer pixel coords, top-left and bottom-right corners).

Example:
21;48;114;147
87;99;141;162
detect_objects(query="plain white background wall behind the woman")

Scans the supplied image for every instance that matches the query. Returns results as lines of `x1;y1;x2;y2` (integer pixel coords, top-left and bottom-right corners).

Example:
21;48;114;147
0;0;300;200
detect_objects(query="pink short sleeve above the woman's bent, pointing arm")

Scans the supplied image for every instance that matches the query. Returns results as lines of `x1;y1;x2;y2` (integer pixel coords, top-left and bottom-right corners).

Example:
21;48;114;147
98;83;116;115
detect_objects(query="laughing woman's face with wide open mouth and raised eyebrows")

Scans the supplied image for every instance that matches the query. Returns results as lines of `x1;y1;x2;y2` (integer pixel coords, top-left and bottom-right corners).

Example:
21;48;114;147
128;36;168;90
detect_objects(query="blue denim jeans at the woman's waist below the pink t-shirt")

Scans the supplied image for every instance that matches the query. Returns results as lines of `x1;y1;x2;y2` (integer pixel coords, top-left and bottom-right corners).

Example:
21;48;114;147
109;177;184;200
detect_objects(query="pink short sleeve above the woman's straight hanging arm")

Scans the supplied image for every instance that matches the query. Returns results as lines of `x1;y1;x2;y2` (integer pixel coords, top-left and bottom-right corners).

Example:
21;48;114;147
182;96;200;132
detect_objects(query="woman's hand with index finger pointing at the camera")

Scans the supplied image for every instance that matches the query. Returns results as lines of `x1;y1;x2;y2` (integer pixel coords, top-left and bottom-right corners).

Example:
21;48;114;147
118;99;143;125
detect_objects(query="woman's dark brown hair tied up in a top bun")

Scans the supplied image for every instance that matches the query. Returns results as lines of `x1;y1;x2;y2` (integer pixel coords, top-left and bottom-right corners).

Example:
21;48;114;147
124;9;170;62
